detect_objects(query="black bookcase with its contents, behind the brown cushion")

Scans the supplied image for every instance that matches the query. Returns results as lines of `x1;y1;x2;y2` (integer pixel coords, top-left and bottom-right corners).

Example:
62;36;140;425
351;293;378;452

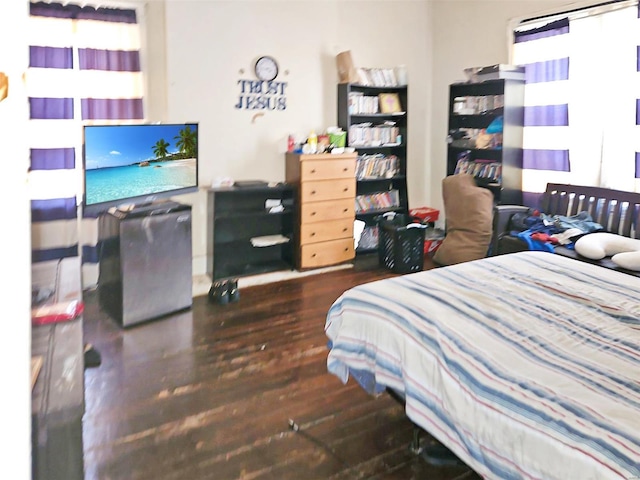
447;79;524;205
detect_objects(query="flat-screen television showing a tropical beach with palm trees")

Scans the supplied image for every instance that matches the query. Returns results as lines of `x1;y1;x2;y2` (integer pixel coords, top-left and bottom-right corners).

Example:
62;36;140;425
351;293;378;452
83;123;198;212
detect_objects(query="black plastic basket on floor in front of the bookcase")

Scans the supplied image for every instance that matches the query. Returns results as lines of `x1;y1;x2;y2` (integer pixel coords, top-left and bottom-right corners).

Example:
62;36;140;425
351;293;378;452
376;214;427;273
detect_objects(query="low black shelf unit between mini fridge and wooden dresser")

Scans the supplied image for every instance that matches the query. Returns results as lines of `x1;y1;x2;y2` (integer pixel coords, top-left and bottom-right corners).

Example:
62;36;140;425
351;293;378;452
207;184;295;281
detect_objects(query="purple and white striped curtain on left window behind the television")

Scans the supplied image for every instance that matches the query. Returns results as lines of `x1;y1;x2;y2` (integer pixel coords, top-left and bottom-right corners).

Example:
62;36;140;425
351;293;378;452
26;2;144;287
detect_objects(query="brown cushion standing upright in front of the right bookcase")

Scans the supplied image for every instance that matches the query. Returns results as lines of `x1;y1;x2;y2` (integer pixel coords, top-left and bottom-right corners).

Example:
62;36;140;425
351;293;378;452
433;175;493;265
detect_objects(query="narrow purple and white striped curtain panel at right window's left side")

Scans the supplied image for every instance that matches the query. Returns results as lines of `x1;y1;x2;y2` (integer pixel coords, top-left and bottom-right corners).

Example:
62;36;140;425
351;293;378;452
513;18;571;207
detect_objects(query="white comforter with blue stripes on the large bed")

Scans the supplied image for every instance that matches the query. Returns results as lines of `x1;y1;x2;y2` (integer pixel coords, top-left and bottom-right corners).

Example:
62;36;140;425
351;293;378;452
325;252;640;480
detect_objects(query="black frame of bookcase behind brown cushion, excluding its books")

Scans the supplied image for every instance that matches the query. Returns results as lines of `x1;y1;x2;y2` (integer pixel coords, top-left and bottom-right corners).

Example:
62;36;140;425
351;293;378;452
447;79;524;205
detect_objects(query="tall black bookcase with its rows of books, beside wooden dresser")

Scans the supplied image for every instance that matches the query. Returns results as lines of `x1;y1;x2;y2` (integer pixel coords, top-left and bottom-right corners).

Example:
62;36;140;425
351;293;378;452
338;82;409;254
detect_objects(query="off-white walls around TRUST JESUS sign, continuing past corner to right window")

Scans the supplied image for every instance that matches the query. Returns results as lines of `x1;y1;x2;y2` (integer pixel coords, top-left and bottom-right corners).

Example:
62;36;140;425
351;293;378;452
155;0;595;275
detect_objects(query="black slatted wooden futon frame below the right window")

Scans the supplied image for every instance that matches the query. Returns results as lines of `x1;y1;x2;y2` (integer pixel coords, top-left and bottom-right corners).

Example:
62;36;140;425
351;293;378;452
490;183;640;276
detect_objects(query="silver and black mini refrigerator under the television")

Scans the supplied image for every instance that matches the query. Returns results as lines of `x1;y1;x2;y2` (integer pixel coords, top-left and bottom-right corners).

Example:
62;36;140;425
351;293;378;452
98;202;193;327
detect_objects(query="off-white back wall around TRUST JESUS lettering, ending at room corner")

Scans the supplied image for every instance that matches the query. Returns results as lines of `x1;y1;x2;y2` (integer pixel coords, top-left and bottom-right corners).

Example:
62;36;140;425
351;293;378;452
156;0;431;274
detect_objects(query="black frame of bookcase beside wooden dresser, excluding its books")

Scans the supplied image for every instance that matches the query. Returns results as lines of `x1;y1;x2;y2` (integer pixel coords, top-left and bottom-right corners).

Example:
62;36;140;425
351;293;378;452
338;83;409;254
